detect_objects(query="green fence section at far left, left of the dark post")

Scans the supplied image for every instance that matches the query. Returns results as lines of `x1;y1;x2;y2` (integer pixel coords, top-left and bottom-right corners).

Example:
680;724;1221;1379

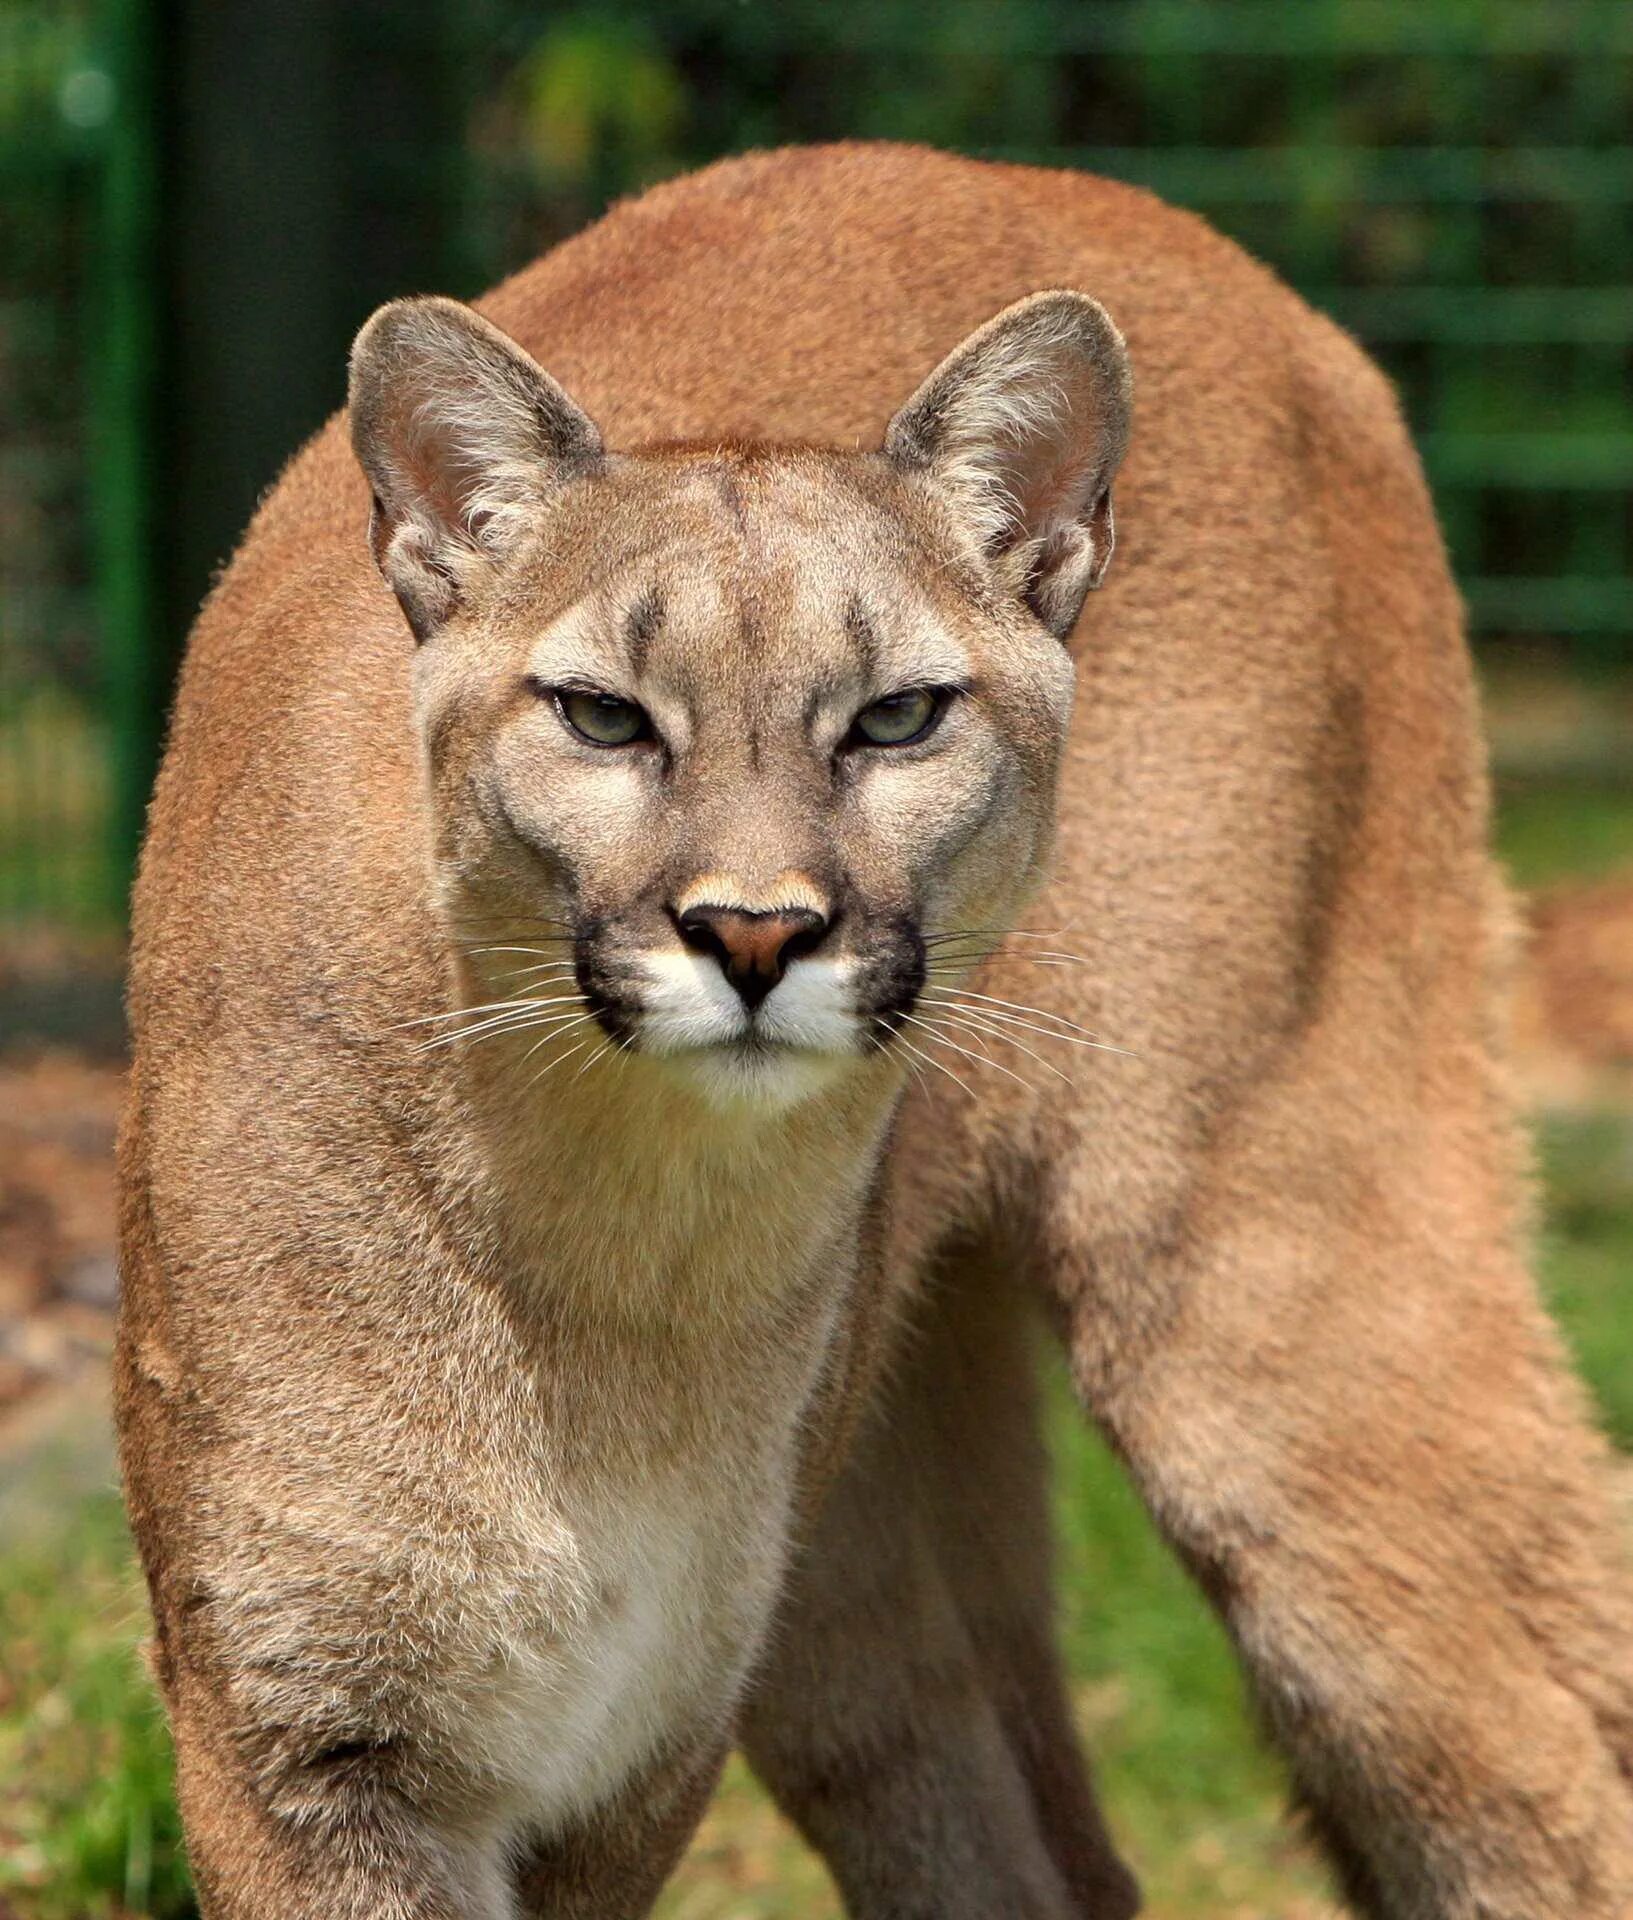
0;0;163;922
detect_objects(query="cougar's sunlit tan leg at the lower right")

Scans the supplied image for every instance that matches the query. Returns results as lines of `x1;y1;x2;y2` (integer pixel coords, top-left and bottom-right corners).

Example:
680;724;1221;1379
1048;1104;1633;1920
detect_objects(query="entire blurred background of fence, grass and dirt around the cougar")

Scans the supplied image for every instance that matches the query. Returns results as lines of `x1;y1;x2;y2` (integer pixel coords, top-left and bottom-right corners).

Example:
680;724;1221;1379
0;0;1633;1920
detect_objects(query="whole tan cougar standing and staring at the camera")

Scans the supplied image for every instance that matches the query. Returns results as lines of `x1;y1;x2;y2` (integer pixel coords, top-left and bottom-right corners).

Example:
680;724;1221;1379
117;146;1633;1920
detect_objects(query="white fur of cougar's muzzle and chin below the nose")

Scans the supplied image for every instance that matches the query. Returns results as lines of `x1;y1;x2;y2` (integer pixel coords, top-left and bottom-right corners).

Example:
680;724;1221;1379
637;952;862;1106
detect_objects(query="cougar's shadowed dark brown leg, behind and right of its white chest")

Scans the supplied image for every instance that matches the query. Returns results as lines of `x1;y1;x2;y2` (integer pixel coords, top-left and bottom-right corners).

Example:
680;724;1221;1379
743;1261;1138;1920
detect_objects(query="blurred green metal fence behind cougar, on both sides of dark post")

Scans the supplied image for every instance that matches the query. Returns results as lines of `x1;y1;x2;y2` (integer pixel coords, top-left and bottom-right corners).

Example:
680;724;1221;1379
0;0;1633;922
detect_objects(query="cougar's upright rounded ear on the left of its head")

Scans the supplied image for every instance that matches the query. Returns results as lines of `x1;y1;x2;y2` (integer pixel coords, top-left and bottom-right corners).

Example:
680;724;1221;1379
347;300;603;639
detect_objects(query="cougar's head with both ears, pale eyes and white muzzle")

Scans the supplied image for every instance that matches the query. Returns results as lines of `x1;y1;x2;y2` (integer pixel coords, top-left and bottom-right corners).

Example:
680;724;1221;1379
351;292;1130;1102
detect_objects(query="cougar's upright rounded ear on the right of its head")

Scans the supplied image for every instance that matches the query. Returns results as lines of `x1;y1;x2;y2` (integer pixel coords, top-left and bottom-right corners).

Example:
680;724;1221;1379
885;292;1132;639
